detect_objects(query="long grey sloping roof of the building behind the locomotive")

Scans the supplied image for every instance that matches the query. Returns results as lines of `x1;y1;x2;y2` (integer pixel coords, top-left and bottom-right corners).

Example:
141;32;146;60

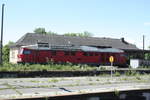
13;33;138;50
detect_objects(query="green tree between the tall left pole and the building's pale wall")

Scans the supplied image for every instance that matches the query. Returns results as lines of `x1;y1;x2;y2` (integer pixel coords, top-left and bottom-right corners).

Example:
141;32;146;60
3;42;14;62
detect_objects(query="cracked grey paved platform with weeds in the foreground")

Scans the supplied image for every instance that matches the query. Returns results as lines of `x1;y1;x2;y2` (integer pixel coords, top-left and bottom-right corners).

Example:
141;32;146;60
0;75;150;99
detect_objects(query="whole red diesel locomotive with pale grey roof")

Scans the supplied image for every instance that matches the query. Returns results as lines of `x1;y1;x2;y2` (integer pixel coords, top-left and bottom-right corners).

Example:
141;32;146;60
18;45;126;66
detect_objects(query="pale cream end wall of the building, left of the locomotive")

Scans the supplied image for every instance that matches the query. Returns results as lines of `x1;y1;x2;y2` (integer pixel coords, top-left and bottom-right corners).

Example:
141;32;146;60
9;48;19;64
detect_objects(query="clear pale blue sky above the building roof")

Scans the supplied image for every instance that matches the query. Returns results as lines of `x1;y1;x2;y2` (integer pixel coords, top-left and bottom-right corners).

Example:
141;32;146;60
0;0;150;48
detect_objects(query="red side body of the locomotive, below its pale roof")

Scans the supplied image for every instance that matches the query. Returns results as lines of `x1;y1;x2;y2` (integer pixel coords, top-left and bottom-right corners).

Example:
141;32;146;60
18;48;126;65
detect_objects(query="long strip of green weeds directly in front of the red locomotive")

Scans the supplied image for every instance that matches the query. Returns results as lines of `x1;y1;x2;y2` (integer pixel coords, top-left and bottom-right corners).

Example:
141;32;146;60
0;63;97;71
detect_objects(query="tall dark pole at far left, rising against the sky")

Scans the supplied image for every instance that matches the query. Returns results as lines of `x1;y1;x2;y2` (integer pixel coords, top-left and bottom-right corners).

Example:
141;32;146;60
0;4;5;65
